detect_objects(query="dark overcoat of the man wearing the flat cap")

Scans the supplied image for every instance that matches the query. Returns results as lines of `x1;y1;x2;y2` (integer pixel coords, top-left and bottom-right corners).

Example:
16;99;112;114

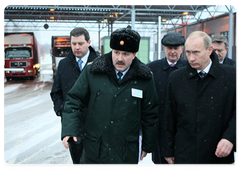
147;57;187;165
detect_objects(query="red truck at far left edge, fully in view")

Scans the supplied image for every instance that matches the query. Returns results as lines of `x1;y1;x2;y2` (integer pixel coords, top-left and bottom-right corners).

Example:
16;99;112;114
4;32;40;80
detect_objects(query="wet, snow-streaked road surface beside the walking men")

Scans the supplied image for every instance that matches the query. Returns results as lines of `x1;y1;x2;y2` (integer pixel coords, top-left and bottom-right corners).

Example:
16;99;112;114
1;64;153;165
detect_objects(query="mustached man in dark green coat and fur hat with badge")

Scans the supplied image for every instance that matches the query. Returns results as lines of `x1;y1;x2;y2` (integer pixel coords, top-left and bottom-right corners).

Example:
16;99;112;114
62;28;158;165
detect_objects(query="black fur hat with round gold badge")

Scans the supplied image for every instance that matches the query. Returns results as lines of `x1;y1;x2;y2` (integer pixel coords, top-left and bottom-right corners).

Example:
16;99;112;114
110;28;141;52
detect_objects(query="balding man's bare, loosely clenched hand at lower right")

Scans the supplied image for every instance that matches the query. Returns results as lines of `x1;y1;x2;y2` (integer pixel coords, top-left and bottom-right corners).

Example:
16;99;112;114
215;139;233;158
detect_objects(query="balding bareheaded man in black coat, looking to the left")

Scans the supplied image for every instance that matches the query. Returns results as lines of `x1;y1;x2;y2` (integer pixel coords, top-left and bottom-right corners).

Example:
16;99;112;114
161;31;237;165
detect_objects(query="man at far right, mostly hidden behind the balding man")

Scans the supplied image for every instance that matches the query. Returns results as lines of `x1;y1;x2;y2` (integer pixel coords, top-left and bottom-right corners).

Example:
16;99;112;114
212;35;237;67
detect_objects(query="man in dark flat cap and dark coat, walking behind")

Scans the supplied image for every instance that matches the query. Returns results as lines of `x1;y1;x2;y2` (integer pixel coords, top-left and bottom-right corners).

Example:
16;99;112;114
147;32;187;165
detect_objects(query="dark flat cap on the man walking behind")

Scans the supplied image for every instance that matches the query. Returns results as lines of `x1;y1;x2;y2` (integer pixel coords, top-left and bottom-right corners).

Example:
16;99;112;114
162;32;185;46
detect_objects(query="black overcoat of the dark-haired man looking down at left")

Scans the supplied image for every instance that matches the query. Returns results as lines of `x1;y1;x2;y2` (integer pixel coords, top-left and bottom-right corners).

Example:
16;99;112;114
50;46;98;116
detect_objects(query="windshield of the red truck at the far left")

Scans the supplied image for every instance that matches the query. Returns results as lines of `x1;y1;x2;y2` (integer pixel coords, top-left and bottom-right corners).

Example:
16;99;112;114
5;48;31;58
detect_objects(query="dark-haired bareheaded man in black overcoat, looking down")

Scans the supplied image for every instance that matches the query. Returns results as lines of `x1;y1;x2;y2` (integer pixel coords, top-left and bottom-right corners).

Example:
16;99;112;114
50;27;97;165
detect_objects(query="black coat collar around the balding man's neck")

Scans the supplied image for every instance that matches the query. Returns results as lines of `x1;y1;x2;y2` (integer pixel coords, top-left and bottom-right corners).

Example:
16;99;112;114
187;51;219;78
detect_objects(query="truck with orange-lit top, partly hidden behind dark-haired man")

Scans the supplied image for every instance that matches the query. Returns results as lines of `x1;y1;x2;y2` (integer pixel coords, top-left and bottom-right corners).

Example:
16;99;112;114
51;36;71;77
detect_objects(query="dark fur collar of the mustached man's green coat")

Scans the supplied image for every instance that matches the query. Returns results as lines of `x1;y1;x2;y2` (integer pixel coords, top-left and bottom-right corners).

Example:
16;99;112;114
90;52;152;82
